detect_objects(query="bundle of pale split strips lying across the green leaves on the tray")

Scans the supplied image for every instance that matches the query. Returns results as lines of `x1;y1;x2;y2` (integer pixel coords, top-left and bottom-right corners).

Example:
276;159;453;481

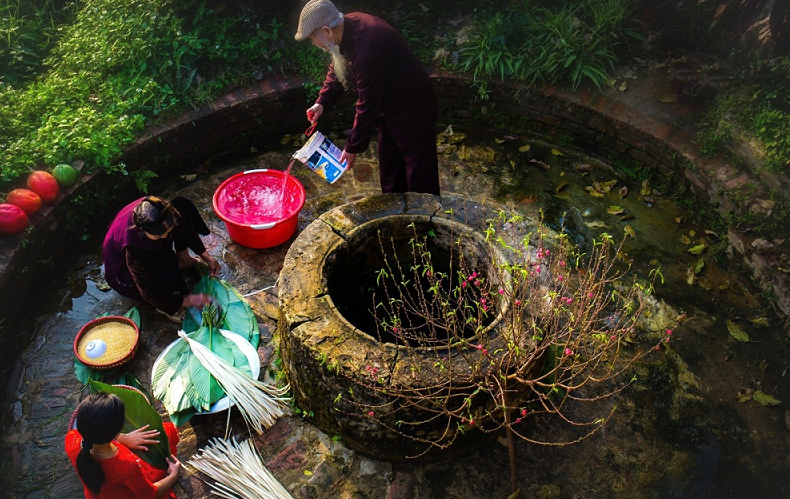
178;331;290;434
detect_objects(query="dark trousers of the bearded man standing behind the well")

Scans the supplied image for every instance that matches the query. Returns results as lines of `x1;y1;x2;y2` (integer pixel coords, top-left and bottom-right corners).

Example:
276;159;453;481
376;115;439;196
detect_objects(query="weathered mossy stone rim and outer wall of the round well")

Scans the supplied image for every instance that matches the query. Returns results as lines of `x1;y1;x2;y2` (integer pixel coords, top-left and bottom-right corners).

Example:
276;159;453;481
278;193;540;461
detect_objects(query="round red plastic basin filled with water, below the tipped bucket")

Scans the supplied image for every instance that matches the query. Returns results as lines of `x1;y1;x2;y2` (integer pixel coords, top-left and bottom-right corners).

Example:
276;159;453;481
213;170;305;249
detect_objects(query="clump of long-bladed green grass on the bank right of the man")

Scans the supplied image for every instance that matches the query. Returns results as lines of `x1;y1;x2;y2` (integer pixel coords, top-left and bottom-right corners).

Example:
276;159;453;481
460;0;641;98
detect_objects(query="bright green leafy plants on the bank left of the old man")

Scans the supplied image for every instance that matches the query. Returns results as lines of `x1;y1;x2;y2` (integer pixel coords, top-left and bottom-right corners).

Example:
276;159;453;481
0;0;325;190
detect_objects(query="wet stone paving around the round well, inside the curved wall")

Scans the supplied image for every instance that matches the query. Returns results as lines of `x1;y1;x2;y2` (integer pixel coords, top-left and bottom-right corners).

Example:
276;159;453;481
0;130;790;499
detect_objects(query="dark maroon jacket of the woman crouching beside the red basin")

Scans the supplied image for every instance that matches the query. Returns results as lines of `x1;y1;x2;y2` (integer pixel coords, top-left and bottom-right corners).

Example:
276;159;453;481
102;198;206;314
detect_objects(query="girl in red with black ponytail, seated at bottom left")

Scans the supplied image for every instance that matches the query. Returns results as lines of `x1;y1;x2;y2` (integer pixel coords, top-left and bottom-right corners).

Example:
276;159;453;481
66;393;181;499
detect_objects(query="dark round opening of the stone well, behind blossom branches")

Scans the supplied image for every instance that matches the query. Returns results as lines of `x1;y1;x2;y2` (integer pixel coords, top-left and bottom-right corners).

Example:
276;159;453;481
323;215;498;347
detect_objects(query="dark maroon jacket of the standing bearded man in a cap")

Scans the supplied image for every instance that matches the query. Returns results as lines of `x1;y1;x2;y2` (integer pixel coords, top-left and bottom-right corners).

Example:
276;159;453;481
316;12;438;154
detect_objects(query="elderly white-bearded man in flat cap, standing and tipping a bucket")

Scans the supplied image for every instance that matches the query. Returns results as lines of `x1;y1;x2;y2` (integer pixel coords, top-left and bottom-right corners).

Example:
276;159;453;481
295;0;439;195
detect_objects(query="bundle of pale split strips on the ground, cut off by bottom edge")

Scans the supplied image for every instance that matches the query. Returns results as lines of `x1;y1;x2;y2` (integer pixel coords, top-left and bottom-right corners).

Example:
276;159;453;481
187;437;293;499
